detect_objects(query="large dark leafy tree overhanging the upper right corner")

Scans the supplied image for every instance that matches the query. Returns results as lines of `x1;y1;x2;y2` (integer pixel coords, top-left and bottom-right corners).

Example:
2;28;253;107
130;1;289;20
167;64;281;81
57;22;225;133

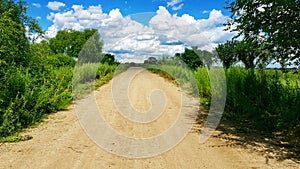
226;0;300;66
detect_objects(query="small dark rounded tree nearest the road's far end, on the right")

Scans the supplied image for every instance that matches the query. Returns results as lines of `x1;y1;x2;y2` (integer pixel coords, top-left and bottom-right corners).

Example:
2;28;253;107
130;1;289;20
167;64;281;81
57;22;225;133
175;48;204;70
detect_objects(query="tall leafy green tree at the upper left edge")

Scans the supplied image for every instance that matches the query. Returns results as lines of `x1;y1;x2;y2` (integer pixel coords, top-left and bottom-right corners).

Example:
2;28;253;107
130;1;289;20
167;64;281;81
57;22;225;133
0;0;43;66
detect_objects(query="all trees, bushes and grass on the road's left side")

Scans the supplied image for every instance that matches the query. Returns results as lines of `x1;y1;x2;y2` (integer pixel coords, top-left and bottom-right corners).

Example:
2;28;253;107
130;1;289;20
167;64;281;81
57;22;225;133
0;0;119;142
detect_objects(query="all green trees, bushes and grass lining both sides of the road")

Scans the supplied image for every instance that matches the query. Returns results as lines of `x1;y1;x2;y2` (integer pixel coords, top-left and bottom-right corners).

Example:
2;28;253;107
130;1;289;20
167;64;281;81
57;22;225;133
0;0;300;159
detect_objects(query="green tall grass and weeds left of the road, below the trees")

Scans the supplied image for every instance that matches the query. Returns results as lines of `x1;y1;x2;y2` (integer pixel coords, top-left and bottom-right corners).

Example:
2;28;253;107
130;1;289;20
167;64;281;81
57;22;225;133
0;64;117;141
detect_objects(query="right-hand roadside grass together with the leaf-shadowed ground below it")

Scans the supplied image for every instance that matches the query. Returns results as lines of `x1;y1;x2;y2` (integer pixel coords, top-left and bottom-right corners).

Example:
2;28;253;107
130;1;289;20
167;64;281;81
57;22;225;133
147;62;300;161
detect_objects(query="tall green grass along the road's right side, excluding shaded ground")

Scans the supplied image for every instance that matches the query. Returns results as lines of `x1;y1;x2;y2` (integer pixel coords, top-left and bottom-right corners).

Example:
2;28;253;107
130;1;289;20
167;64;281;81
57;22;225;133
155;65;300;132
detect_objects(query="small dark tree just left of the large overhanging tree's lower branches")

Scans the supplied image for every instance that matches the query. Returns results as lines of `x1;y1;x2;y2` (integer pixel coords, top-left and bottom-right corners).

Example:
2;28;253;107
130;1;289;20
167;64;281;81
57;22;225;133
216;41;238;69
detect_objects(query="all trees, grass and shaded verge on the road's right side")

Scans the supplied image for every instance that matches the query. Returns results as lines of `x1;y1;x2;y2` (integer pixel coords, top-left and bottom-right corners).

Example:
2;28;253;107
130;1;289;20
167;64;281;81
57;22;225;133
145;0;300;160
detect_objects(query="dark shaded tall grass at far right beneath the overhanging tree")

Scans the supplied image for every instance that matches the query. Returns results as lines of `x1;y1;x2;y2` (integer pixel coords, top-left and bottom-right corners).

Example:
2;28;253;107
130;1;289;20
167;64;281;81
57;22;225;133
225;68;300;131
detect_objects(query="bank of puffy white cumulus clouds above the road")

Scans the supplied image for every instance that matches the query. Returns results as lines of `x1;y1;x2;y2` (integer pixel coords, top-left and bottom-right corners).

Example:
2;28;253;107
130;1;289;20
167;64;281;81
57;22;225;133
46;5;234;62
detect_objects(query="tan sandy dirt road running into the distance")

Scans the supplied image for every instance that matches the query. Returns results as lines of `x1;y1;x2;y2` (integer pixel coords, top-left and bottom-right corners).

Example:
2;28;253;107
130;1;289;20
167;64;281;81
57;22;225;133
0;67;299;169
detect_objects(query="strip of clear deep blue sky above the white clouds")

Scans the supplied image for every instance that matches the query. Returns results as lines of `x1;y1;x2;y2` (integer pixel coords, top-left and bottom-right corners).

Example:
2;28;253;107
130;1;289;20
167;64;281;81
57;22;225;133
27;0;229;29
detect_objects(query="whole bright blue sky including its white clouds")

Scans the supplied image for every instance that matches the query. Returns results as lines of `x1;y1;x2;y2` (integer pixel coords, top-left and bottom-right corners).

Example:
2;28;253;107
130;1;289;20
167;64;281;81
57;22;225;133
27;0;234;62
